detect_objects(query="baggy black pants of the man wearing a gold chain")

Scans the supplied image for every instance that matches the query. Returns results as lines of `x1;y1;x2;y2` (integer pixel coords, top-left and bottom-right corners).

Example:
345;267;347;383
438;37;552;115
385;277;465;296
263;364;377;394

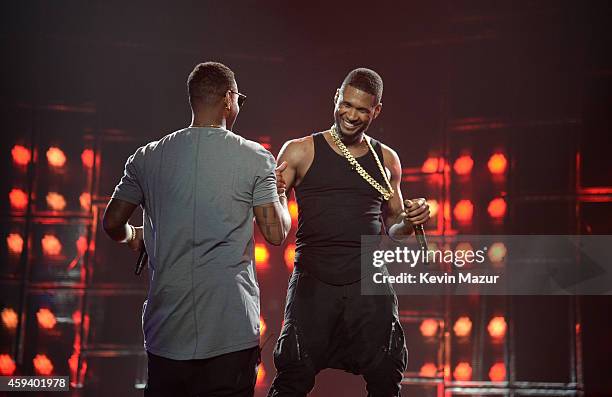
268;270;407;397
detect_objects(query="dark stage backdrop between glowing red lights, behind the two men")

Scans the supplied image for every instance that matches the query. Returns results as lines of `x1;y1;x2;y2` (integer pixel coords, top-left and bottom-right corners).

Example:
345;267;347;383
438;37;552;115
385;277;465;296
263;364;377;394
0;0;612;396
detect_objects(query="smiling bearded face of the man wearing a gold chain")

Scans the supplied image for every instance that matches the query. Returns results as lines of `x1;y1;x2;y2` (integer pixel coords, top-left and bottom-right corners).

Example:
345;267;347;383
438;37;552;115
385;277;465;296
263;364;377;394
334;85;382;143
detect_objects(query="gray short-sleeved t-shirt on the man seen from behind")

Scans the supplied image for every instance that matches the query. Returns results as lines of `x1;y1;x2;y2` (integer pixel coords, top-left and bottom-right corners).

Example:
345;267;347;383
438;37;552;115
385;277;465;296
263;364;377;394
112;128;278;360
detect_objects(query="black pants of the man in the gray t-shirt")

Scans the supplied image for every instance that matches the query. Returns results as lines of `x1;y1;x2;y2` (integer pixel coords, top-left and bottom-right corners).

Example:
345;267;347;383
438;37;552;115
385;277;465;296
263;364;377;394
144;346;260;397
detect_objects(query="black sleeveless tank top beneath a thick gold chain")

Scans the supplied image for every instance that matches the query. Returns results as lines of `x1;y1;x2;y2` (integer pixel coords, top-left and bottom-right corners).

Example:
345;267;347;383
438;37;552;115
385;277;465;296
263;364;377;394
295;132;386;285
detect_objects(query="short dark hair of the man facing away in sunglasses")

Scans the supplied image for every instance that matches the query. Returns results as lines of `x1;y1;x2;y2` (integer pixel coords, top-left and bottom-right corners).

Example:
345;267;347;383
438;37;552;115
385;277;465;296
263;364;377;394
187;62;235;105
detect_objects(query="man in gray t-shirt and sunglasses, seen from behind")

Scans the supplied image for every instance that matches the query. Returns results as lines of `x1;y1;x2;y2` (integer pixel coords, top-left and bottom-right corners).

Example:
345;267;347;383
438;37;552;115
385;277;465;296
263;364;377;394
104;62;291;396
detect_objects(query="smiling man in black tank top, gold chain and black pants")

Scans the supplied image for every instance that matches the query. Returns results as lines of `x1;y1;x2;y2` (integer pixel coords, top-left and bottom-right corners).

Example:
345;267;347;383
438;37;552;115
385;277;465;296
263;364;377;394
268;68;429;397
